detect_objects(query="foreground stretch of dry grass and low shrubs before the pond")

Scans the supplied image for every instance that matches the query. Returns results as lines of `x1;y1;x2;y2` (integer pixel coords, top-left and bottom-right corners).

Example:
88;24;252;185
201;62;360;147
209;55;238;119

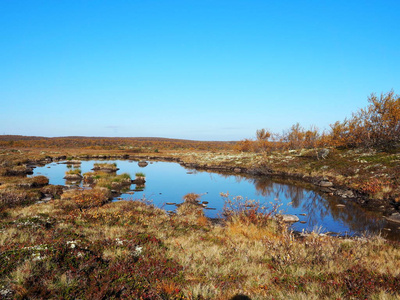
0;193;400;299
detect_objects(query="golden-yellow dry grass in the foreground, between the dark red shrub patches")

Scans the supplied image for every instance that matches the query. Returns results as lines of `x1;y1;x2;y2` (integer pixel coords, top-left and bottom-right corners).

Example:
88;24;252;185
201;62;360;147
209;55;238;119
0;196;400;299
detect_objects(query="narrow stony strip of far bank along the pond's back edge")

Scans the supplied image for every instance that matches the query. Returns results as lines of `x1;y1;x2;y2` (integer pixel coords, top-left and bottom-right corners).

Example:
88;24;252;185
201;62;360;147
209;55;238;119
12;150;399;221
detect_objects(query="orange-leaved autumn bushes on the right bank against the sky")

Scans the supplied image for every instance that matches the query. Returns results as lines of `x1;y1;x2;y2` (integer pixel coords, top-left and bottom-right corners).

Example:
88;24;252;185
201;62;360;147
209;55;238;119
236;91;400;152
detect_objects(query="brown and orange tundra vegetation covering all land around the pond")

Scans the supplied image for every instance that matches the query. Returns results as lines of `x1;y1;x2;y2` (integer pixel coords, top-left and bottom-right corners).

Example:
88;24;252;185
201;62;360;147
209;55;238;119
0;92;400;300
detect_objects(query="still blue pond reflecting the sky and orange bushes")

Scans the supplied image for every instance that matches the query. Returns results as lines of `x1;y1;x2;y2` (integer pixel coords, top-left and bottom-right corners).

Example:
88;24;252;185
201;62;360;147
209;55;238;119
32;160;400;238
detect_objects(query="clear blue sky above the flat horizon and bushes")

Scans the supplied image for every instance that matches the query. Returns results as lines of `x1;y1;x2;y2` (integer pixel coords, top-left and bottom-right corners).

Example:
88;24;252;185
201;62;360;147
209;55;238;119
0;0;400;140
